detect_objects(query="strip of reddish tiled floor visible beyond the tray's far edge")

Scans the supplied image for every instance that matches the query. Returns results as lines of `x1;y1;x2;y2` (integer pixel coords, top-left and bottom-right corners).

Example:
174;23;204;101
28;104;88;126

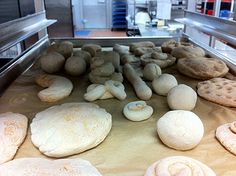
75;29;126;38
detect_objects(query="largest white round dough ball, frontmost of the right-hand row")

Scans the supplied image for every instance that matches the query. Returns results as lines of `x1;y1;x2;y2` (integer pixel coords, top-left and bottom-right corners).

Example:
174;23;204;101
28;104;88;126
157;110;204;150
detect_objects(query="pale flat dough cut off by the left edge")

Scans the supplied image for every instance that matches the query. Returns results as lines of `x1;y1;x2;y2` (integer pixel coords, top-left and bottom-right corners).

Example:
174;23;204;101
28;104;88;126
0;112;28;164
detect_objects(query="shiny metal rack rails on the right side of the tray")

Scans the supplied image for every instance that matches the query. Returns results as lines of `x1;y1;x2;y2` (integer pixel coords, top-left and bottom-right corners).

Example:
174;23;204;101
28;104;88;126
176;11;236;73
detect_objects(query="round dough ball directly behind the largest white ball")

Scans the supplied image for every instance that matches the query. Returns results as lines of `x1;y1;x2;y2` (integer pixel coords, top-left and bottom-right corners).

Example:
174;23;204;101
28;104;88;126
167;84;197;111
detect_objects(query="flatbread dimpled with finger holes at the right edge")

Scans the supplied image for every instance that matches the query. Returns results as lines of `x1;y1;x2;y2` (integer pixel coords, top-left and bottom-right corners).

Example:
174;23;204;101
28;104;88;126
197;78;236;107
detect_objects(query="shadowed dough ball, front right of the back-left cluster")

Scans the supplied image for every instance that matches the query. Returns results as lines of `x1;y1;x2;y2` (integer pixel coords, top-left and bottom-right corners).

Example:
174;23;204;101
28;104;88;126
65;56;86;76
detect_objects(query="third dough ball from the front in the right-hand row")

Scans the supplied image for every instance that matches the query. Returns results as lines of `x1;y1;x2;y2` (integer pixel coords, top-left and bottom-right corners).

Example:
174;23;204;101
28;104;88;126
152;74;178;96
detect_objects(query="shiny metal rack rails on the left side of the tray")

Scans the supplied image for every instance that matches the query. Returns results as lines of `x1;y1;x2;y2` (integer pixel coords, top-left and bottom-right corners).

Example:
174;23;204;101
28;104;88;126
0;11;56;92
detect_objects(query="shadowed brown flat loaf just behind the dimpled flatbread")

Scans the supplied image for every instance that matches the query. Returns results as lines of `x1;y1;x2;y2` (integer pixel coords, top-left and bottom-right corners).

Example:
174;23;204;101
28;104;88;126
177;57;229;80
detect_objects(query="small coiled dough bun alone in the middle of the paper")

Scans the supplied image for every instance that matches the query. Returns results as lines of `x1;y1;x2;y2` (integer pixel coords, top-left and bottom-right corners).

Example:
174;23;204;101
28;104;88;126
123;101;153;122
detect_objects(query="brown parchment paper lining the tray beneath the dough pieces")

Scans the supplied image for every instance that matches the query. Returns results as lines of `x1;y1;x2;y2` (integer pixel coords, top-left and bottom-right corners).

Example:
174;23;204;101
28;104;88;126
0;42;236;176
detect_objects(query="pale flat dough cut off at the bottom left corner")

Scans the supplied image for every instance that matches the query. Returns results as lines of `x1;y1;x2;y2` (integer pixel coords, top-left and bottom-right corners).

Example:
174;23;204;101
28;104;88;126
0;158;102;176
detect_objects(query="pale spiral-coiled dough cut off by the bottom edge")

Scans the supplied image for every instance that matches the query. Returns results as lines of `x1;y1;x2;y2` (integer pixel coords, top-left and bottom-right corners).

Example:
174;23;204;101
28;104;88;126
144;156;216;176
